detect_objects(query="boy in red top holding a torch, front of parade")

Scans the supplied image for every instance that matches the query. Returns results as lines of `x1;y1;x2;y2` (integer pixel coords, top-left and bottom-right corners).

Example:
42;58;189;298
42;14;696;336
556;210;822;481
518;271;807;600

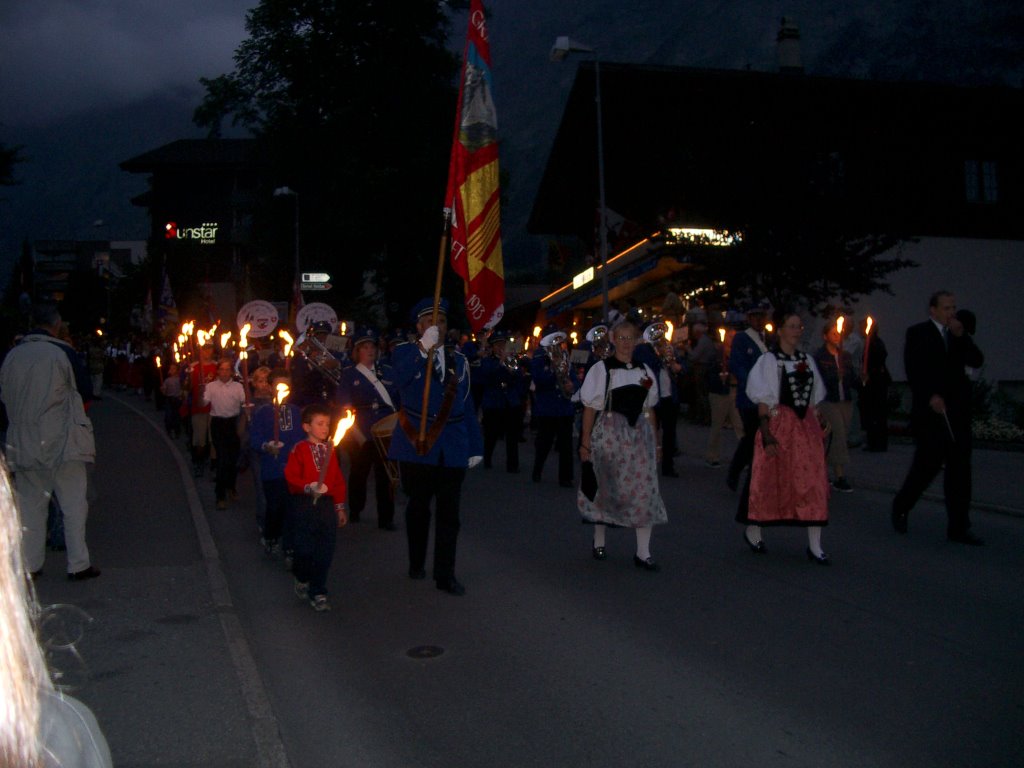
285;403;348;610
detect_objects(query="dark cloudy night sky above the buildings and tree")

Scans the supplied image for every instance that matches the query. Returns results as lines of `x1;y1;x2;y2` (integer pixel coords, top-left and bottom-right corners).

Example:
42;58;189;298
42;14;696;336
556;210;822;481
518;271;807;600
0;0;1024;283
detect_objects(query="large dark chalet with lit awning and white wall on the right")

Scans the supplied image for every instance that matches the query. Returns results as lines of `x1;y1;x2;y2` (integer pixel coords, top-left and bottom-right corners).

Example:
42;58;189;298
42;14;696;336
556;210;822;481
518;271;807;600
528;62;1024;382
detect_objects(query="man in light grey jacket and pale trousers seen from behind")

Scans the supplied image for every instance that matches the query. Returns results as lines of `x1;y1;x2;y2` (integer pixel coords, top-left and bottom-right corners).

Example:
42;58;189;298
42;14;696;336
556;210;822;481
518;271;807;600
0;304;99;581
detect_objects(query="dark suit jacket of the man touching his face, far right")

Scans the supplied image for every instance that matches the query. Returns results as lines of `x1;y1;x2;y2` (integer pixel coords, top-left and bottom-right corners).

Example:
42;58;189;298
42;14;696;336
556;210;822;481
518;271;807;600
903;319;985;437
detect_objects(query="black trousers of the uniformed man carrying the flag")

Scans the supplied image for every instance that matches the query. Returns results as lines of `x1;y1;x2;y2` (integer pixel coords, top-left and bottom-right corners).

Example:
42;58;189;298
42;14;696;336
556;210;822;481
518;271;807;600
399;462;466;585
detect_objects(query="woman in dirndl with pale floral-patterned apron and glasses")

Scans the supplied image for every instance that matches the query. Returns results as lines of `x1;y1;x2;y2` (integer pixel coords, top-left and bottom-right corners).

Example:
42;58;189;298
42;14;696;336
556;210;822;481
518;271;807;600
577;321;669;570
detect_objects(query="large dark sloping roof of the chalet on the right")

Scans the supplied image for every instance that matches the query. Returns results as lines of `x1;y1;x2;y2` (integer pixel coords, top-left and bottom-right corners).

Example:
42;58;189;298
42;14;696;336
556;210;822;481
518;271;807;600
528;61;1024;241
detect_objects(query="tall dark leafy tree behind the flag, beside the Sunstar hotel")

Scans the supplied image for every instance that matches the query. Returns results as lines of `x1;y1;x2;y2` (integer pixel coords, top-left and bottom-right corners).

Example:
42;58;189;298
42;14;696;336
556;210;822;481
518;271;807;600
194;0;466;325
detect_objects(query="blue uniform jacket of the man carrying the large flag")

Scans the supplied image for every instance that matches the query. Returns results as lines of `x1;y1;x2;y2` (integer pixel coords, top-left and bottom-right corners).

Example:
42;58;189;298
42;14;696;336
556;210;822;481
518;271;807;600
388;343;483;468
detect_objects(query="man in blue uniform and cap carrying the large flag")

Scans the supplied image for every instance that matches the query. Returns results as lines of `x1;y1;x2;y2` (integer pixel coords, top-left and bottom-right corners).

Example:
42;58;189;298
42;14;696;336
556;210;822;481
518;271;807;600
388;299;483;595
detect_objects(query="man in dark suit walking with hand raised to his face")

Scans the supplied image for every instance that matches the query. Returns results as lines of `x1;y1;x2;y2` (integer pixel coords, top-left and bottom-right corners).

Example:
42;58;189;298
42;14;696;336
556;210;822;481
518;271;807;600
892;291;984;546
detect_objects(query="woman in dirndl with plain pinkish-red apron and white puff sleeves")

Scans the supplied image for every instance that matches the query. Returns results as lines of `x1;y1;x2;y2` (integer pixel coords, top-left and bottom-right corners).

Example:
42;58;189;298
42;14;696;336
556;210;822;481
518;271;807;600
736;309;829;565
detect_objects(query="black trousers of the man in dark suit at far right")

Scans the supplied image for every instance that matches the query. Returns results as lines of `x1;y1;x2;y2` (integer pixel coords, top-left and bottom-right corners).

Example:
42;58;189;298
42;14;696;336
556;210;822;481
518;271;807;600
893;414;972;536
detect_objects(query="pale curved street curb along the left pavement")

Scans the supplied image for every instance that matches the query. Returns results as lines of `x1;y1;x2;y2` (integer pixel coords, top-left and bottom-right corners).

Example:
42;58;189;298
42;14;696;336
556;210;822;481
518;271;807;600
103;393;291;768
